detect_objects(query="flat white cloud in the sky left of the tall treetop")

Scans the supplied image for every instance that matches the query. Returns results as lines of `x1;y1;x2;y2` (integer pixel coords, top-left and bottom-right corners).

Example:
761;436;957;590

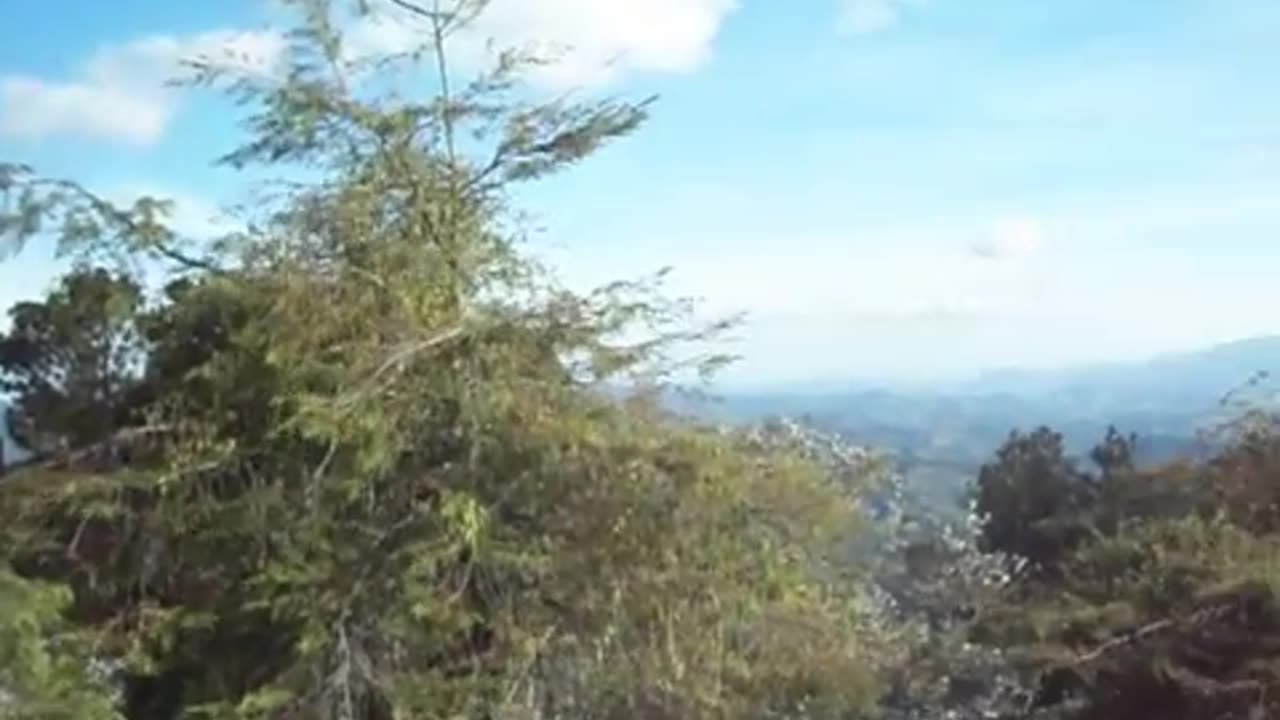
0;31;284;145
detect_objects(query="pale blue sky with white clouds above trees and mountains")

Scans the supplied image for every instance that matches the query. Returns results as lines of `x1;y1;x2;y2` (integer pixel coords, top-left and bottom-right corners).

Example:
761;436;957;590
0;0;1280;382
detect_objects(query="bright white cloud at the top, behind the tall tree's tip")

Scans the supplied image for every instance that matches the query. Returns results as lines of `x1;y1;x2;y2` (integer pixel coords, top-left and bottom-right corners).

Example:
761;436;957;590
348;0;739;90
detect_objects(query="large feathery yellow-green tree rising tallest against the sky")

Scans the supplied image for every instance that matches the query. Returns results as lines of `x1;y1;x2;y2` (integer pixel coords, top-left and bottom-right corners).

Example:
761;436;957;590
0;0;884;720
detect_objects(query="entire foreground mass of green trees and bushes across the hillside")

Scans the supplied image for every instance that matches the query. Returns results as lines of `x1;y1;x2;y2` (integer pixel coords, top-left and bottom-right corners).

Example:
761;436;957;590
0;0;1280;720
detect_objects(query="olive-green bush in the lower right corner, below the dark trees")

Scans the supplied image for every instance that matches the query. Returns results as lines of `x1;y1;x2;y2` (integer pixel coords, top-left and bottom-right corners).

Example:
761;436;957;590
986;518;1280;720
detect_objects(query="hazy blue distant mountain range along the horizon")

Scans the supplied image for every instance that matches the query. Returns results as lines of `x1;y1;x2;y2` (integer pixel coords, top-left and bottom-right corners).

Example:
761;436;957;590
684;337;1280;507
